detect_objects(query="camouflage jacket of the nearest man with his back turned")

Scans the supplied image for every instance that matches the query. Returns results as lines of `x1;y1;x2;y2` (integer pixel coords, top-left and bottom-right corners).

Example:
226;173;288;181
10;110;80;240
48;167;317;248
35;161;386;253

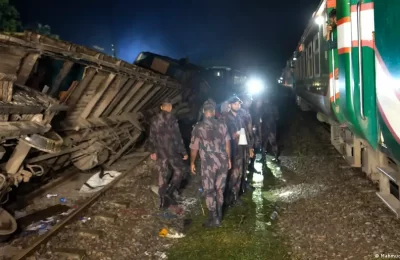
190;118;231;159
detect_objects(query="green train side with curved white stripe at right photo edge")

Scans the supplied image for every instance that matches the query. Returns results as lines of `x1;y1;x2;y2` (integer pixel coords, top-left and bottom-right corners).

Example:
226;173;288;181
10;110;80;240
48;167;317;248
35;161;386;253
374;0;400;161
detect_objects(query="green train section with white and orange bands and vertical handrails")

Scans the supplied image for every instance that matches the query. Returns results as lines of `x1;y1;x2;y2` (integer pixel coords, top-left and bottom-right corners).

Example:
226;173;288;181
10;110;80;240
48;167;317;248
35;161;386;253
337;0;378;149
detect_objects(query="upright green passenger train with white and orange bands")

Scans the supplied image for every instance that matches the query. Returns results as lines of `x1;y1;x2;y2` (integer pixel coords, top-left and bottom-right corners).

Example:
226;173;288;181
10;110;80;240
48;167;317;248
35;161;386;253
279;0;400;215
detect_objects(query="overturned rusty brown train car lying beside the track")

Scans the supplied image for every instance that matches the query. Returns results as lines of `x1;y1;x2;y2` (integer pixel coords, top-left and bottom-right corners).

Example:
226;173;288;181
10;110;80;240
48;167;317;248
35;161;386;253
0;32;182;223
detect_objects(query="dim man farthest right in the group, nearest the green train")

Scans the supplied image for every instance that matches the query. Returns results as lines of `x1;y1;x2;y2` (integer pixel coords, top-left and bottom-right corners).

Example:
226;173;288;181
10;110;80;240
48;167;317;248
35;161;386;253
261;98;279;162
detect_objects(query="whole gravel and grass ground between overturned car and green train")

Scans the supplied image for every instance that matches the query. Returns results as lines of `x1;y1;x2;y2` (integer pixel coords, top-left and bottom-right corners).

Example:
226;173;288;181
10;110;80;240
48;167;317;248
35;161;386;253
5;103;400;260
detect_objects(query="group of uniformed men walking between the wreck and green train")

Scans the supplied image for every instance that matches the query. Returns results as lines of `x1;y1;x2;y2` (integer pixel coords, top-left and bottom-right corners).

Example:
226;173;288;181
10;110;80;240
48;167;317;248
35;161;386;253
149;94;279;227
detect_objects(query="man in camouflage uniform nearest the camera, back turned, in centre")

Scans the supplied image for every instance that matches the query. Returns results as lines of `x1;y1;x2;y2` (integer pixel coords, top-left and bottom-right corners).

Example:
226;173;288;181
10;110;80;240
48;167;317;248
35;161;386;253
190;100;230;227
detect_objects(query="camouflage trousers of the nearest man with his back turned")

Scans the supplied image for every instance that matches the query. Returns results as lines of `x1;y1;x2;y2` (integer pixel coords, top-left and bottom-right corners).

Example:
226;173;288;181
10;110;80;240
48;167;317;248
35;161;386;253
201;153;228;211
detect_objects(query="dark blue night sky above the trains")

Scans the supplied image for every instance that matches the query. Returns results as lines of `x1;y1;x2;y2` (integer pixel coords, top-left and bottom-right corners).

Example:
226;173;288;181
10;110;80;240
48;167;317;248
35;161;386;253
14;0;319;77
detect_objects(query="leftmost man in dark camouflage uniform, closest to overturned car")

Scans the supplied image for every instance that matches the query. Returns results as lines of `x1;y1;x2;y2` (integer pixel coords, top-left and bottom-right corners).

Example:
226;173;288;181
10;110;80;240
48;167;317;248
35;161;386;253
149;99;188;208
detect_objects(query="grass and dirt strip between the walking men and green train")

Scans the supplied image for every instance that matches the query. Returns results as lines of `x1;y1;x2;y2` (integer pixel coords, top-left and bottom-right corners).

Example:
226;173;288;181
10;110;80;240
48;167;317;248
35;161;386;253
168;111;400;260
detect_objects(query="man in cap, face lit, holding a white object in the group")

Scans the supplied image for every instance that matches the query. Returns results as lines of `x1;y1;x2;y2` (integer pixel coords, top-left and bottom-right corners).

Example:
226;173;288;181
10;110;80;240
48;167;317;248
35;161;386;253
225;96;254;205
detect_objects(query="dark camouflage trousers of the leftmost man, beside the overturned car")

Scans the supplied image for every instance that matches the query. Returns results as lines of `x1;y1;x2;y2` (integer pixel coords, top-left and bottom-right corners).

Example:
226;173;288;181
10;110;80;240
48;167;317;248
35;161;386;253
156;156;185;194
